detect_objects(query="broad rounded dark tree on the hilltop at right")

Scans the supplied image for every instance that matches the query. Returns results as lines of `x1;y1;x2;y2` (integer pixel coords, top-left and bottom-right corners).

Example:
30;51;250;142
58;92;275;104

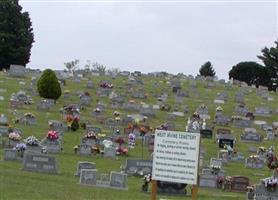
229;61;269;86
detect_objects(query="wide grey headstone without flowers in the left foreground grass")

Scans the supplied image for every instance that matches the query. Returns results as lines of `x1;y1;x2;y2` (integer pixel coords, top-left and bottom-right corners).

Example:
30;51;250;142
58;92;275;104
23;152;58;174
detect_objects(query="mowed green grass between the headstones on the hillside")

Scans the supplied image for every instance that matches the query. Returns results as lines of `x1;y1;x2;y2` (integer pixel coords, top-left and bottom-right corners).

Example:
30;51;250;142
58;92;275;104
0;72;278;200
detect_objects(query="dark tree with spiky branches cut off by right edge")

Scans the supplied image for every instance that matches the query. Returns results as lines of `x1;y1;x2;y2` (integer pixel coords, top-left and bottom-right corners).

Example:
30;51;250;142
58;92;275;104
258;40;278;90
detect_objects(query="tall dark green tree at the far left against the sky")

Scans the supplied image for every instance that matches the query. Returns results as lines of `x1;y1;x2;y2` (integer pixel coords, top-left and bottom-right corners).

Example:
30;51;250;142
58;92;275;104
0;0;34;70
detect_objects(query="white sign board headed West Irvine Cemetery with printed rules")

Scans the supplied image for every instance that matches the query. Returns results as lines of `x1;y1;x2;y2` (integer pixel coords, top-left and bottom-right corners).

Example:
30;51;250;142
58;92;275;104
152;130;200;185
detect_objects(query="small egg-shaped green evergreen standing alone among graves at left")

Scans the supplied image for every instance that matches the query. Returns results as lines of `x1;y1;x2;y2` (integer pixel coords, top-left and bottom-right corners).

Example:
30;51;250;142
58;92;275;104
37;69;62;101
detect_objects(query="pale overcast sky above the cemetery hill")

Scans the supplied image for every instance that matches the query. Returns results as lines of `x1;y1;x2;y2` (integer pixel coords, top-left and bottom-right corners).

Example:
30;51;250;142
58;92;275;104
20;0;278;79
